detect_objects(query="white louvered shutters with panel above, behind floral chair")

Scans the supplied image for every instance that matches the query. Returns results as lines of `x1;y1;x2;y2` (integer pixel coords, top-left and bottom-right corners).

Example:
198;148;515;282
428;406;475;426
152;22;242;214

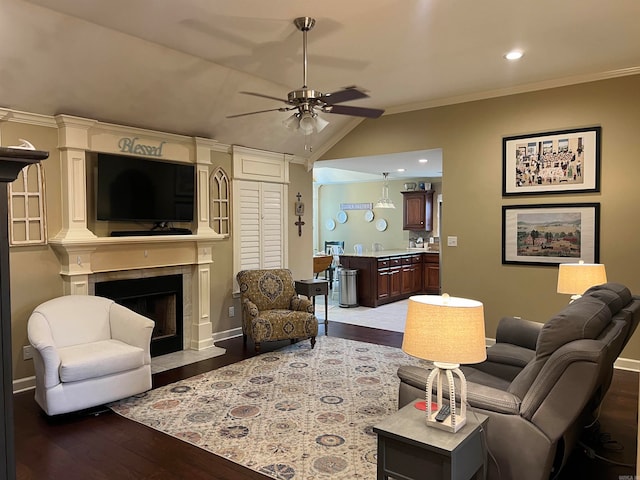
232;147;290;284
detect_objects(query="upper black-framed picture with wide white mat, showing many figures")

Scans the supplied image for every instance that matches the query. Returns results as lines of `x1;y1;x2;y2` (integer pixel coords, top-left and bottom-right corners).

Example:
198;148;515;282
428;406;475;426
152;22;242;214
502;126;601;197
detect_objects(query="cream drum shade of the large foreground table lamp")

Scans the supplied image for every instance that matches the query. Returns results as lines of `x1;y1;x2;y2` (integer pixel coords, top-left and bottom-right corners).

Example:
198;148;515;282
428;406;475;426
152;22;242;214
402;294;487;364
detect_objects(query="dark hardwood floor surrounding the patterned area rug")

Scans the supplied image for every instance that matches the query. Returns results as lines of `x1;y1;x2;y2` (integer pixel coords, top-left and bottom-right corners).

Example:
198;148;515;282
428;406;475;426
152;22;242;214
14;322;638;480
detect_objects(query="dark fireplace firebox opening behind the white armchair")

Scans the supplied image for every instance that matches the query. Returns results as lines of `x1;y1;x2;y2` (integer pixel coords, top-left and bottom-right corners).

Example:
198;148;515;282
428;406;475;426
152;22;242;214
95;275;183;357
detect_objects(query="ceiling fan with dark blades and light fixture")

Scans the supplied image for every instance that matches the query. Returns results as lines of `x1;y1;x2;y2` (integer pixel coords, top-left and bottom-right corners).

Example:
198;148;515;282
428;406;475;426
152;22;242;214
227;17;384;134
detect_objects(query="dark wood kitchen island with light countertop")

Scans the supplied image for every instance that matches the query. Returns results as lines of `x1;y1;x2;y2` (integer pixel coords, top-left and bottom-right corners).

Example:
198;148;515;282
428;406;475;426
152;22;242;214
340;249;440;307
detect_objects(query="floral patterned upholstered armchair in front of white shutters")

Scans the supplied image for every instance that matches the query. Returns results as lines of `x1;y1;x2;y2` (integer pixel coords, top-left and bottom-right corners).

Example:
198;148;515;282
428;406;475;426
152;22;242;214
236;268;318;352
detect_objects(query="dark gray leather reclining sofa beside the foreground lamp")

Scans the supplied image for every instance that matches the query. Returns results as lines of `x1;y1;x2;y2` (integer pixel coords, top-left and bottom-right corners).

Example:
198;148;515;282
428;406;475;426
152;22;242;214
398;283;640;480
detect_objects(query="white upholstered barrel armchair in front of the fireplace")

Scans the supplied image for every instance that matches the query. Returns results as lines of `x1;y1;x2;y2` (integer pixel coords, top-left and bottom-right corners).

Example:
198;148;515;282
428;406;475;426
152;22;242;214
27;295;155;415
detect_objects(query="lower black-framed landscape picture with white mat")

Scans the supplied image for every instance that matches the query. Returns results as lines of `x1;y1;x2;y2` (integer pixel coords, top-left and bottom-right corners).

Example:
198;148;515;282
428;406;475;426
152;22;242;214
502;203;600;266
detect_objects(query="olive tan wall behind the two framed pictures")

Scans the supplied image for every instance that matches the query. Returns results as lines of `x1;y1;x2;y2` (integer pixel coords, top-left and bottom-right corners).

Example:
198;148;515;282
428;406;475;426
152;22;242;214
316;75;640;360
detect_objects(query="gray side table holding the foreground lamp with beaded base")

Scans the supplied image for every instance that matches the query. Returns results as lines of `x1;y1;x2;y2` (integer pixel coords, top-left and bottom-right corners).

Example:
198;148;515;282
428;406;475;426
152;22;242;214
373;402;489;480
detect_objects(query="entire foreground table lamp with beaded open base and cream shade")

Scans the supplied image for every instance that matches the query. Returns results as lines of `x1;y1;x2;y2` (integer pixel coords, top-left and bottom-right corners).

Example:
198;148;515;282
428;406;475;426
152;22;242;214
402;293;487;432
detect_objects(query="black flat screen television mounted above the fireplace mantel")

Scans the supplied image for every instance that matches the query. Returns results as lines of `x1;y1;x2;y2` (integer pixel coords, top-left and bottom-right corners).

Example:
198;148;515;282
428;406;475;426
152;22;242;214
96;153;195;224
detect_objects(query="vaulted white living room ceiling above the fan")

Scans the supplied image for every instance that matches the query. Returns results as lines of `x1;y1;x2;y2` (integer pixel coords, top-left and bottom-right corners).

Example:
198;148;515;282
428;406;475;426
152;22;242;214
0;0;640;171
